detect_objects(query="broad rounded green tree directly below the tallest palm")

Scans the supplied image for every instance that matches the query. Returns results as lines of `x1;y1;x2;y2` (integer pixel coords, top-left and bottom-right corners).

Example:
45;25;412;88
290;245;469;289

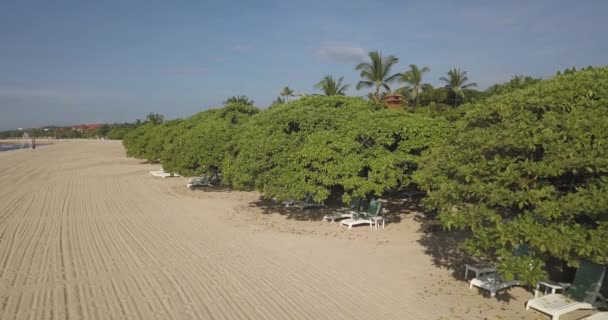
223;96;449;201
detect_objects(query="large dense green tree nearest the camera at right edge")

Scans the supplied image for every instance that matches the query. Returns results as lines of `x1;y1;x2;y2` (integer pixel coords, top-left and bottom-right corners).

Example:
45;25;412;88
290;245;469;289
416;68;608;284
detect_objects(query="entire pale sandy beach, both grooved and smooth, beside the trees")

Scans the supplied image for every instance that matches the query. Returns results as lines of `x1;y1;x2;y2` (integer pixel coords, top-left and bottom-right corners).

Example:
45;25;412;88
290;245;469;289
0;141;585;320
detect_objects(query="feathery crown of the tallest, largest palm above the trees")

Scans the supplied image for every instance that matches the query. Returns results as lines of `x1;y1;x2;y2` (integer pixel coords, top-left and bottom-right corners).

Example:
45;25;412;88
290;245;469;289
355;51;401;100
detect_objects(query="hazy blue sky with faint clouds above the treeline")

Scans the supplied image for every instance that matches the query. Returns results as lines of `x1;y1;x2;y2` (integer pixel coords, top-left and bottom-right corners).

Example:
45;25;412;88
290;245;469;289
0;0;608;130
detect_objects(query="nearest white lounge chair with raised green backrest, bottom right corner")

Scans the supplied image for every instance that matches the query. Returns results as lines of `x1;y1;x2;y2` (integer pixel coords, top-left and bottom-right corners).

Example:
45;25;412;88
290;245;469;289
526;261;606;320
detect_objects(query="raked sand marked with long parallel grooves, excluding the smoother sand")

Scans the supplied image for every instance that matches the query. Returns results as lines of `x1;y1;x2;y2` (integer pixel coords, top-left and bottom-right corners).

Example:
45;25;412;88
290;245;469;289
0;141;452;320
